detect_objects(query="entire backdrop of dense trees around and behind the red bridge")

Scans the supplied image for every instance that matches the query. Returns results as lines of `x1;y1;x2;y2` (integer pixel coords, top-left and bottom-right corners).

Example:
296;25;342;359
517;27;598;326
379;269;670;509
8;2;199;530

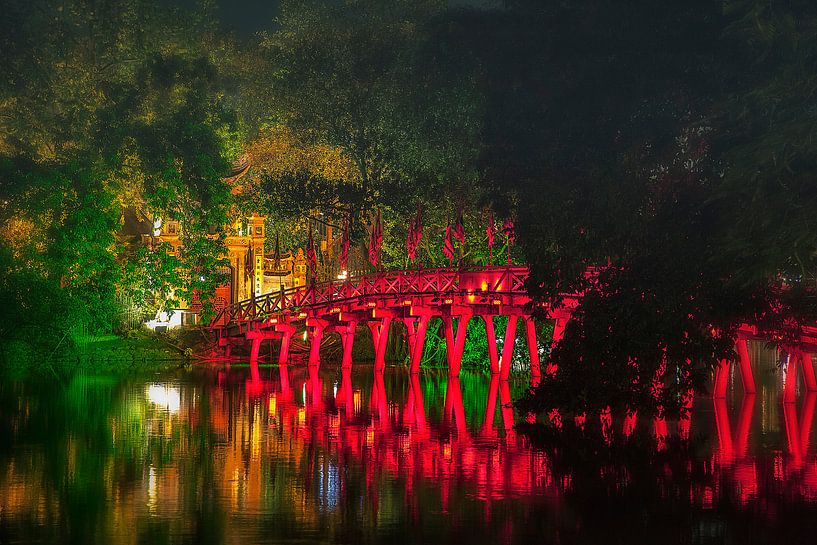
0;0;817;412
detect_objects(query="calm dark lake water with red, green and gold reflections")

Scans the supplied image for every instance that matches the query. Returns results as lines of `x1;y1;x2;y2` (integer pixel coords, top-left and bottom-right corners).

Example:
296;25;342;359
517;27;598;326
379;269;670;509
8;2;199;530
0;346;817;545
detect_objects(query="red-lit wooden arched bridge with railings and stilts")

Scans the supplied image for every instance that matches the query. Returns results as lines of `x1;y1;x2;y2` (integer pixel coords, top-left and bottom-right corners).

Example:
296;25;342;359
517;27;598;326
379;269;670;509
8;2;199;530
211;266;817;401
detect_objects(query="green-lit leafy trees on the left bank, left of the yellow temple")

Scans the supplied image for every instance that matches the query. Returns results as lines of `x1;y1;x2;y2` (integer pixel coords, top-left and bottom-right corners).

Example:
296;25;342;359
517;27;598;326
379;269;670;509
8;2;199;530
0;0;241;366
